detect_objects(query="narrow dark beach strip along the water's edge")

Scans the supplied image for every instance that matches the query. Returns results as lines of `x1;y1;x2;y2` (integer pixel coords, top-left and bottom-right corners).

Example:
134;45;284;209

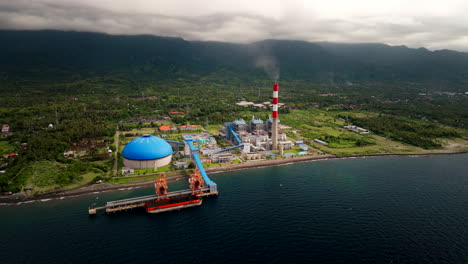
0;151;468;206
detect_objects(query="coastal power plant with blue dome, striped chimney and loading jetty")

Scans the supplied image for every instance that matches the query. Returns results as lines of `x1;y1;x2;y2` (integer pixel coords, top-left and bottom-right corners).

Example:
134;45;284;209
89;82;294;215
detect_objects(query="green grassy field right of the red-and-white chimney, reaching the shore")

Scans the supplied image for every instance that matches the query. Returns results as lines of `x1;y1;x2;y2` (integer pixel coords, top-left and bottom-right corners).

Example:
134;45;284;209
281;109;467;155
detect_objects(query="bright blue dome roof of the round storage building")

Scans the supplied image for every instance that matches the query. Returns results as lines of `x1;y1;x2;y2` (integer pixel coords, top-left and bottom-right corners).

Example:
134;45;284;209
122;135;172;160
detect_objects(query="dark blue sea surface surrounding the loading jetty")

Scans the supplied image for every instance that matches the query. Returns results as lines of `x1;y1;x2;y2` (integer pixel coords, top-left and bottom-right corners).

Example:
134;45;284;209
0;154;468;264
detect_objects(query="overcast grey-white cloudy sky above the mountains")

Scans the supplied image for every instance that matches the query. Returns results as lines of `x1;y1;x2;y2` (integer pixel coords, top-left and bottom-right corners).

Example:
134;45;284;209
0;0;468;51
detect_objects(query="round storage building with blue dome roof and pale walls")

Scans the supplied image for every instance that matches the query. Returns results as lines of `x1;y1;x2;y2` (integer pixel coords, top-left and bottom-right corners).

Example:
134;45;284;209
122;134;173;169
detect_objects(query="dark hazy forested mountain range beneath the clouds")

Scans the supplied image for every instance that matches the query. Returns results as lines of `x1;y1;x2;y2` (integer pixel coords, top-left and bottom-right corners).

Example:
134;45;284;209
0;30;468;83
